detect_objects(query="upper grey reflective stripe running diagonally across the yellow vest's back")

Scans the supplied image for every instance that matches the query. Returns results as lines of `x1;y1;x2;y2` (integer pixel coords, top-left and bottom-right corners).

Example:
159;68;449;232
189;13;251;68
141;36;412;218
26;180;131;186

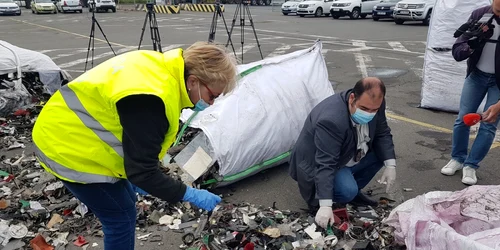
59;85;123;158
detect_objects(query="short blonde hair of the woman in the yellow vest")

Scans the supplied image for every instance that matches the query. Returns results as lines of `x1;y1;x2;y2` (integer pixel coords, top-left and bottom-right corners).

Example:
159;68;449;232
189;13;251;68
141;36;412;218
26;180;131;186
183;42;237;94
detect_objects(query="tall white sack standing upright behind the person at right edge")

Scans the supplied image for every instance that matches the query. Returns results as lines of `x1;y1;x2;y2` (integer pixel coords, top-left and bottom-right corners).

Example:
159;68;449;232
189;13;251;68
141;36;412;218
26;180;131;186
421;0;491;112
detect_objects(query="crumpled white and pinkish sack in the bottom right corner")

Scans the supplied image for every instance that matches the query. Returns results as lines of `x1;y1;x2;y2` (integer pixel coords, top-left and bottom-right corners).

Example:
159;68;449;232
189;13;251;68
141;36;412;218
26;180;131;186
384;185;500;250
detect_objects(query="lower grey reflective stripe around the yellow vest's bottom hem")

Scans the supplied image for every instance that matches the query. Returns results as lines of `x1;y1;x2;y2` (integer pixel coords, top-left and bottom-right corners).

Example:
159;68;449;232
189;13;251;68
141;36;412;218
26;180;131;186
35;145;120;183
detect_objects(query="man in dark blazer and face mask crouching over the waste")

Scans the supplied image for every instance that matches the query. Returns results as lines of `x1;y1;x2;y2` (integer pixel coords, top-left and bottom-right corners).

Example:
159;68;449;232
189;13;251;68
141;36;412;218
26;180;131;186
290;77;396;228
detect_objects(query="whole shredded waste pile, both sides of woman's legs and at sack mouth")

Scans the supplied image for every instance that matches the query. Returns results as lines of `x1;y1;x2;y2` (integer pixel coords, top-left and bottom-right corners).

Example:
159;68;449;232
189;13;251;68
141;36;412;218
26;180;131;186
0;110;405;250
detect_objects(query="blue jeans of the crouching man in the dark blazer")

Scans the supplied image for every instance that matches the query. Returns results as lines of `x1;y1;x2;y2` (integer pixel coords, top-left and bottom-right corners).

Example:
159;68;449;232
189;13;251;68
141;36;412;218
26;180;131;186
333;152;384;203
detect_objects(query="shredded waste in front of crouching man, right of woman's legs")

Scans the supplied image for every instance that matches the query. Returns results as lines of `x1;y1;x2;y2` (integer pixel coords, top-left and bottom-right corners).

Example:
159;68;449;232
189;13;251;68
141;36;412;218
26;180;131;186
134;192;406;250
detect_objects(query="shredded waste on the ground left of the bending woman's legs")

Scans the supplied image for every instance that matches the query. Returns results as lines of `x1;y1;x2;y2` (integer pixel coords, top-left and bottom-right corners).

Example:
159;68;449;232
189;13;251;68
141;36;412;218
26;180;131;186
0;103;102;249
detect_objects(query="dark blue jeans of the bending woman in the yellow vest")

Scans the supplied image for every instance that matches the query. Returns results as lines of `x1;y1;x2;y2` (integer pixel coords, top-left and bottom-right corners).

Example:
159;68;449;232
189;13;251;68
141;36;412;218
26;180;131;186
63;180;137;250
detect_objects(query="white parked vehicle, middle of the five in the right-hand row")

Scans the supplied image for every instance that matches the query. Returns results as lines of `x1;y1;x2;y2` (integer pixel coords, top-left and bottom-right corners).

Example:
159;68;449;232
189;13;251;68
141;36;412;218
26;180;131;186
330;0;380;19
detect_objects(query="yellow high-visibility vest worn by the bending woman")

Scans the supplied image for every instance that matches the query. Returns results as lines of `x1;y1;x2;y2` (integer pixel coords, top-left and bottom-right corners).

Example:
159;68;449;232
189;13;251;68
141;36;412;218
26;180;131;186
32;49;194;183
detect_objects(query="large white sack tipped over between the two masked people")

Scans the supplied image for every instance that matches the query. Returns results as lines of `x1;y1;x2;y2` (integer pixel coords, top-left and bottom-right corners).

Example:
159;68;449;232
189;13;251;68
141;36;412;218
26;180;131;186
181;41;334;177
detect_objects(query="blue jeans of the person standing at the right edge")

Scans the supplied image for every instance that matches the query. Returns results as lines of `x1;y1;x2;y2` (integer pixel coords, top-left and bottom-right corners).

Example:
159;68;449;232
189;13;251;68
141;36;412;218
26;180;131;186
451;69;500;169
